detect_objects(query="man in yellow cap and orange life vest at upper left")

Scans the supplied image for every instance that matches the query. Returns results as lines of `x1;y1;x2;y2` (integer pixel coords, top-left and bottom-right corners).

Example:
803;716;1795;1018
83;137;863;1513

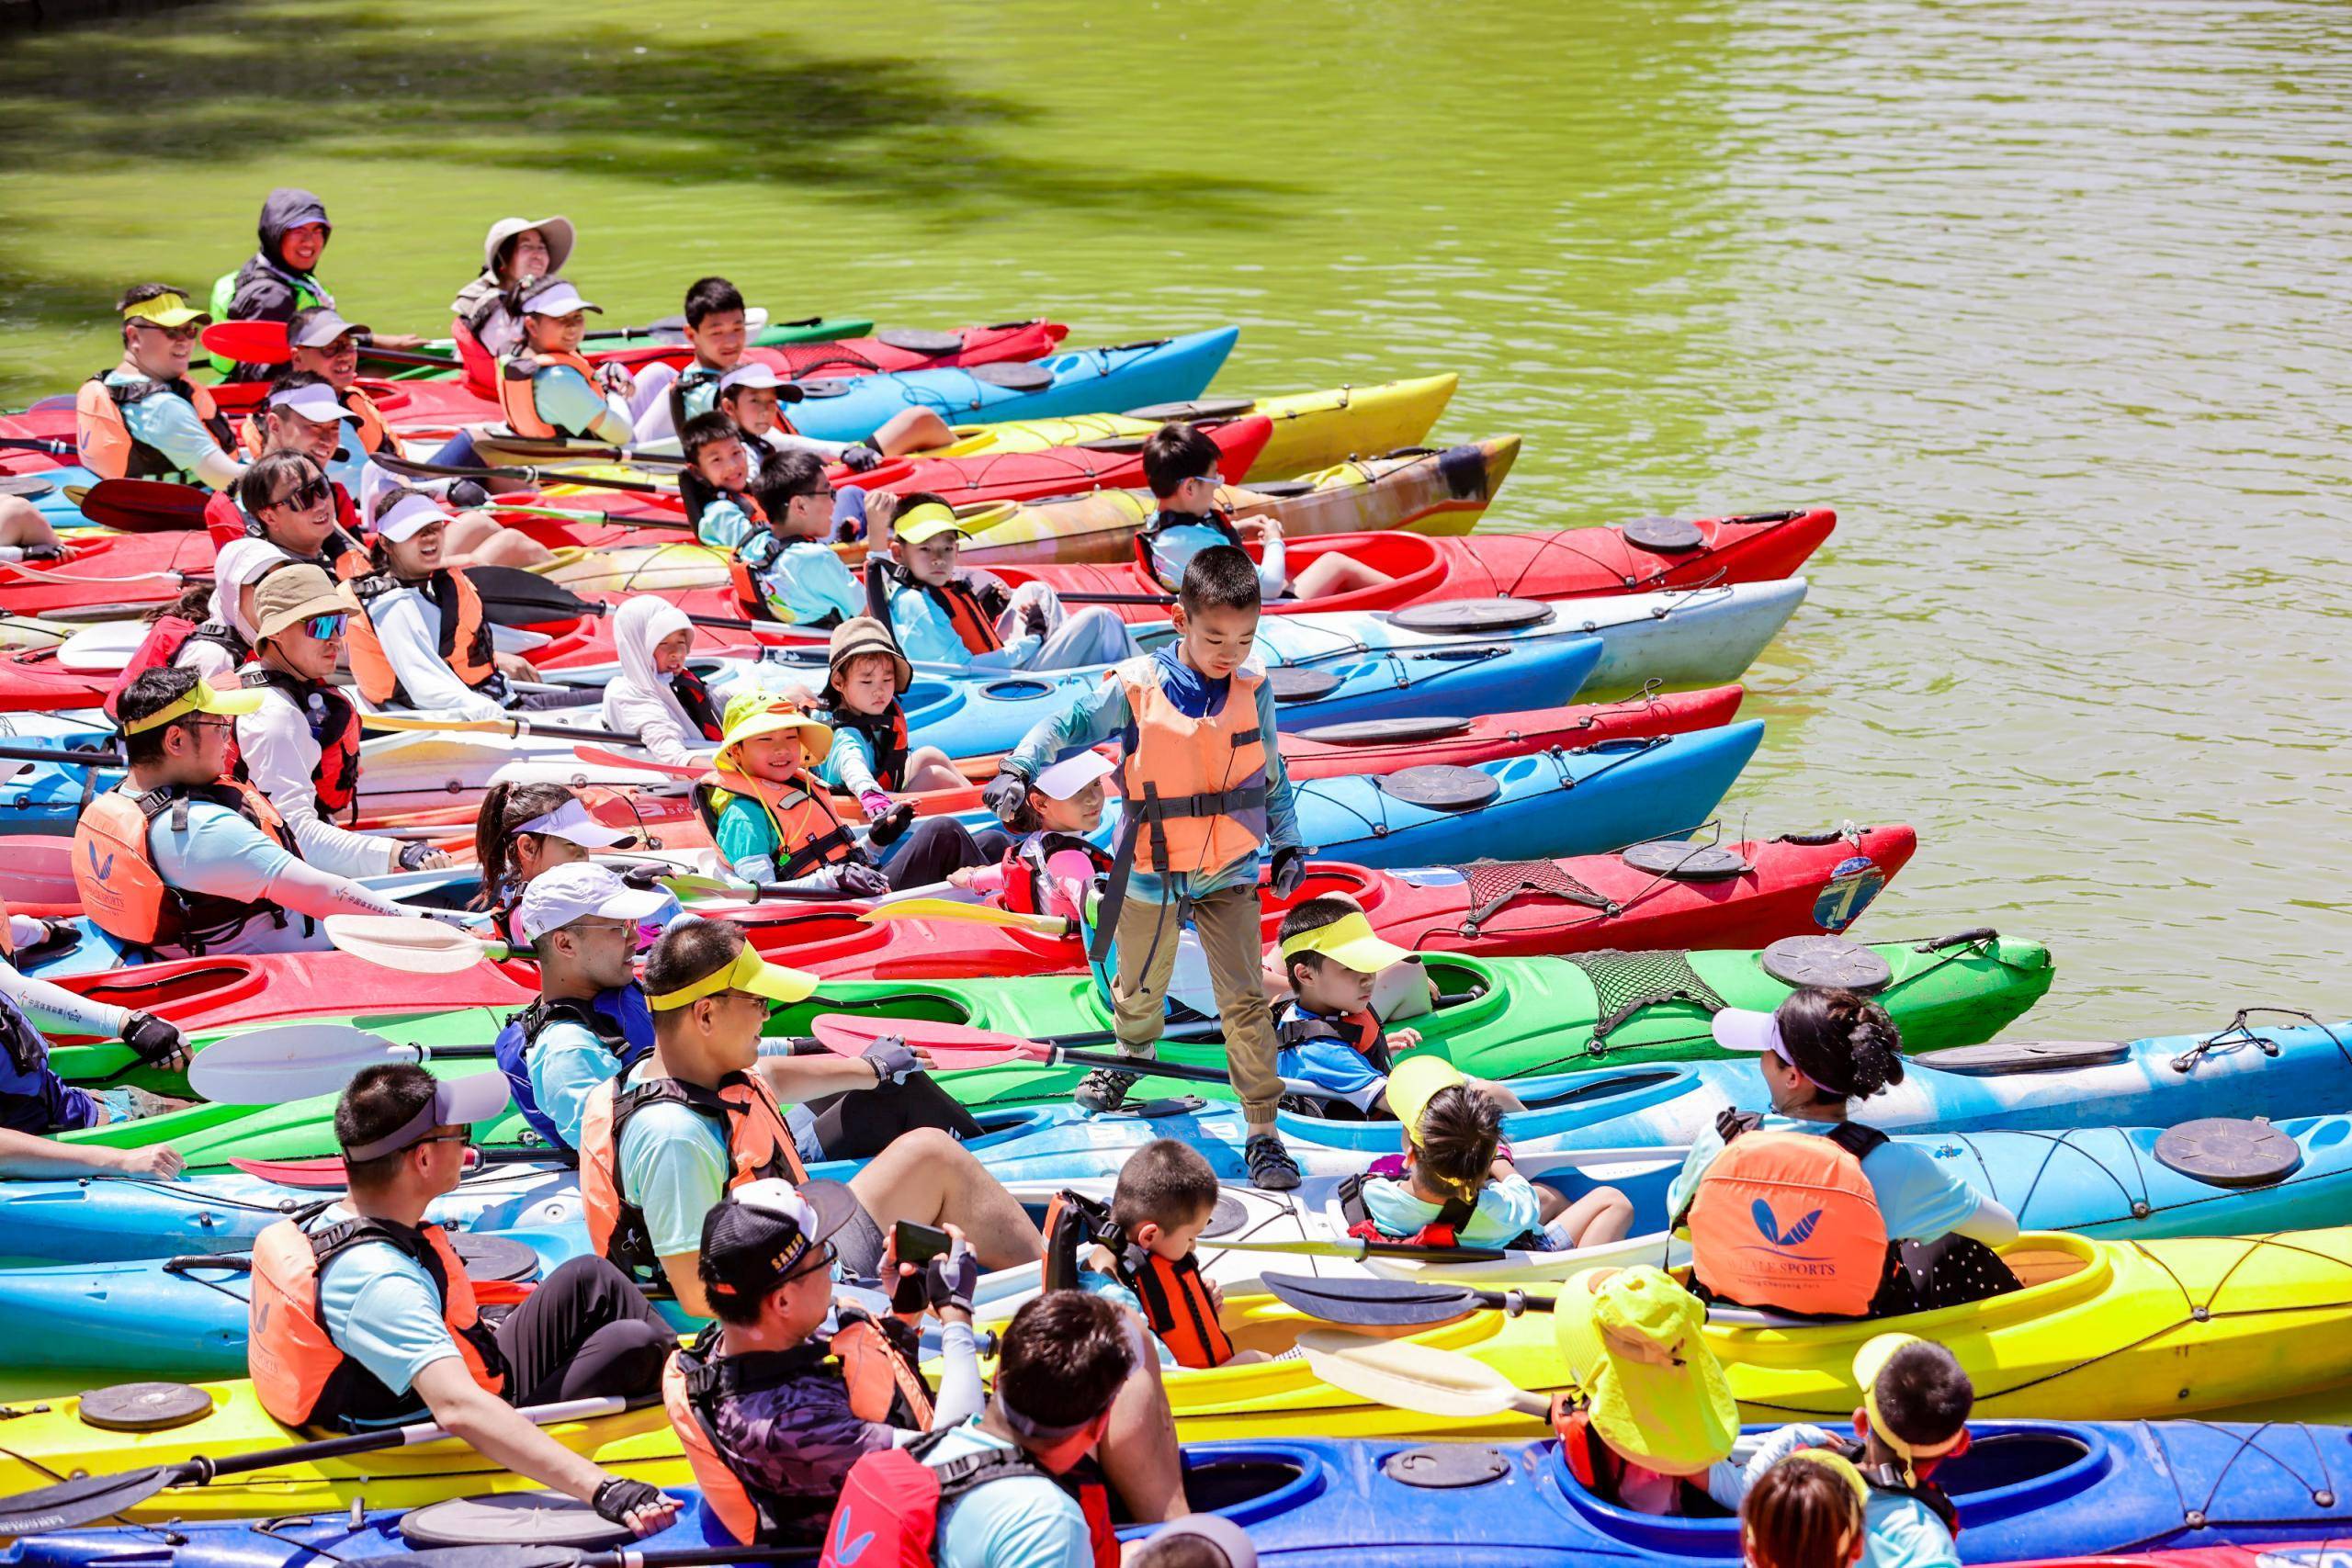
73;282;244;489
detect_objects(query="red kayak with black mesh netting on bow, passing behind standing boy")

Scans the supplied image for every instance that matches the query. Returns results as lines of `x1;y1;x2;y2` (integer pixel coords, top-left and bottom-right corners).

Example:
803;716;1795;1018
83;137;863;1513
28;825;1919;1043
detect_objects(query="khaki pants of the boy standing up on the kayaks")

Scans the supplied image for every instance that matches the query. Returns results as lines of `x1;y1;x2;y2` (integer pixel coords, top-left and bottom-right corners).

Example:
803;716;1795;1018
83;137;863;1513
1110;882;1282;1126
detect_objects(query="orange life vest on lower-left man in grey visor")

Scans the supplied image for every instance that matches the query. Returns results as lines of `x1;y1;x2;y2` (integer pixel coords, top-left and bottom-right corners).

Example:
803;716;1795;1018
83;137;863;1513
244;1220;505;1427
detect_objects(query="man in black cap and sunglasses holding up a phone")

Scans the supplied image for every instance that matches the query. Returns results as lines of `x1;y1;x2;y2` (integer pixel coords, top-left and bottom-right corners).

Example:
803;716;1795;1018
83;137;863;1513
663;1180;986;1547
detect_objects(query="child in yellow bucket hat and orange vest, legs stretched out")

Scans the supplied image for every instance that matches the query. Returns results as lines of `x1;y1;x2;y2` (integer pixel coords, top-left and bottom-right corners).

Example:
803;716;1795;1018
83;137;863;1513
696;691;988;898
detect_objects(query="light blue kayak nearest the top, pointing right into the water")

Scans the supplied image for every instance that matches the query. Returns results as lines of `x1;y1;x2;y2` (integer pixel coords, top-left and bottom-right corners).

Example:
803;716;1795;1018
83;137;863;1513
786;327;1242;442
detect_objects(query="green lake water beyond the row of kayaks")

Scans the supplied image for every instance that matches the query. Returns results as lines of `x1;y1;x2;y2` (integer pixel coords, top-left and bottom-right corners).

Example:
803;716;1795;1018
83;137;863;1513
0;0;2352;1043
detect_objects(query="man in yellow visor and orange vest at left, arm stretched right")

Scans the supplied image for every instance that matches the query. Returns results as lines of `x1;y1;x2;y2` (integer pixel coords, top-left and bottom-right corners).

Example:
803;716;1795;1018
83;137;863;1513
73;668;419;959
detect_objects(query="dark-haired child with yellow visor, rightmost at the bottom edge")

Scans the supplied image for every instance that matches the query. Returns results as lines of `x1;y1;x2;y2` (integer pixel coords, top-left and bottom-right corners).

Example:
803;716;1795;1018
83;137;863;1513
1710;1333;1975;1568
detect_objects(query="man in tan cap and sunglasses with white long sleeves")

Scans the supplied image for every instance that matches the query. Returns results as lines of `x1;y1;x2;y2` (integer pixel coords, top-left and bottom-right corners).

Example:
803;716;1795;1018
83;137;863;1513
231;564;449;877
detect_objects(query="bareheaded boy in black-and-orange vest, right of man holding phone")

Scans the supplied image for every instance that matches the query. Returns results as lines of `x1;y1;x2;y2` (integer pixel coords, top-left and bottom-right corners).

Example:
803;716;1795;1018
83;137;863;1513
1046;1138;1268;1368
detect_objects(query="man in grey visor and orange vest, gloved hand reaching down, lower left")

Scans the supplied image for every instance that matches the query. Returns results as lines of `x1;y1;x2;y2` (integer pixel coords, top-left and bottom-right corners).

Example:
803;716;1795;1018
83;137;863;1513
244;1063;677;1535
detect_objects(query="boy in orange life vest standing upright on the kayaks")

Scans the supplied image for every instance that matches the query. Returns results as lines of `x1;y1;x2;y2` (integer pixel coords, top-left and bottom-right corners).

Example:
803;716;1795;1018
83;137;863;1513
981;546;1306;1192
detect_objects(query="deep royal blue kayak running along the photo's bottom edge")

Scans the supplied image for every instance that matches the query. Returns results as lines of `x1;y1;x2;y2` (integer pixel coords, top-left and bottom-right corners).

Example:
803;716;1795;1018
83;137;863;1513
18;1420;2352;1568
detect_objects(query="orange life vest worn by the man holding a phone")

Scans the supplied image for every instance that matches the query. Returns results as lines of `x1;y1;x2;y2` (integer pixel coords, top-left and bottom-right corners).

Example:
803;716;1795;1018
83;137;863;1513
661;1304;932;1547
